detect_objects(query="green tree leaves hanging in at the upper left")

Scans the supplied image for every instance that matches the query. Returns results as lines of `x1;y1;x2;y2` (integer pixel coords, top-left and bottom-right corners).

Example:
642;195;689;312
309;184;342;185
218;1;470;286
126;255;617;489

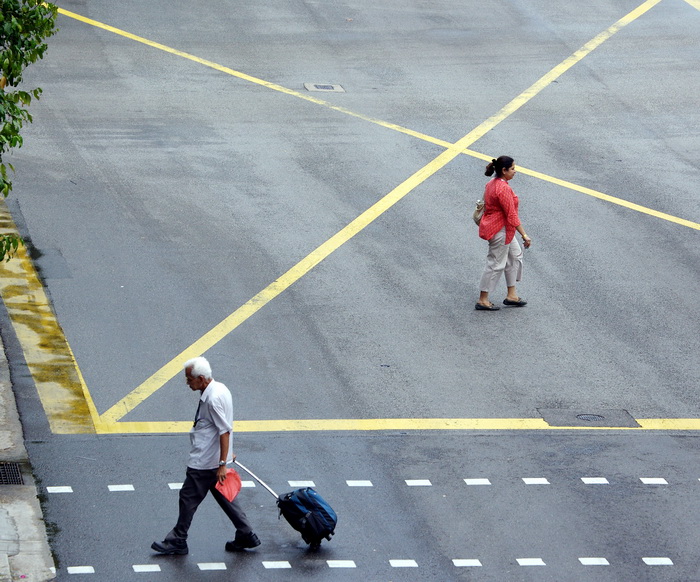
0;0;58;259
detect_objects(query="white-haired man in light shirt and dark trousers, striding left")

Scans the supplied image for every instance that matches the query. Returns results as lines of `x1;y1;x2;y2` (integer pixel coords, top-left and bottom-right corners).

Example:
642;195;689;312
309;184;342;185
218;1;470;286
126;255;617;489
151;358;260;554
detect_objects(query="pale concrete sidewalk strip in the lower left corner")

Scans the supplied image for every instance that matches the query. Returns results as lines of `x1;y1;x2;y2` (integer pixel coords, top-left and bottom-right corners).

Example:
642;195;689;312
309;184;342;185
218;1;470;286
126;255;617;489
0;340;56;582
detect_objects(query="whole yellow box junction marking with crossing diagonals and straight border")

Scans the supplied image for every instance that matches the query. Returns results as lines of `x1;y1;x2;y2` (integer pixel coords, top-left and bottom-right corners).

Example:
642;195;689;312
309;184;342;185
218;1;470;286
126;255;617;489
3;0;700;433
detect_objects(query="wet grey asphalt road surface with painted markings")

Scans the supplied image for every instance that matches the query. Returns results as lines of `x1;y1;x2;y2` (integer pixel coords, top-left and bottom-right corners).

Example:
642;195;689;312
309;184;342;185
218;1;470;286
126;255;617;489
2;0;700;582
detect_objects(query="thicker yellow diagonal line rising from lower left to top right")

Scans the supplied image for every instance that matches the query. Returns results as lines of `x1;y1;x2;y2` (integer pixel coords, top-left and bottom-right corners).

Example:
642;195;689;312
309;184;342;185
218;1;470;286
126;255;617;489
100;0;661;424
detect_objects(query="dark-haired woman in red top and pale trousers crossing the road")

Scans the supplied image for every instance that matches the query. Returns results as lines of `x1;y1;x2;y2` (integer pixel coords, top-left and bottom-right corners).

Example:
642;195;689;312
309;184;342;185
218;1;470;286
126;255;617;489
474;156;532;311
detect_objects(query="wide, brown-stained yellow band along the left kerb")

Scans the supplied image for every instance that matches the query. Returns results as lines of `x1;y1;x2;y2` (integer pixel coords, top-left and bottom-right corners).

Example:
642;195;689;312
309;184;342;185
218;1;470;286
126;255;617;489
0;198;99;434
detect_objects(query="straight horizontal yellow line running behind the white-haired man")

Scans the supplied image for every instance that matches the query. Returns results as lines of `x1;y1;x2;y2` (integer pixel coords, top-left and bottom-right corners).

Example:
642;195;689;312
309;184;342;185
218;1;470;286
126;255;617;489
95;418;700;434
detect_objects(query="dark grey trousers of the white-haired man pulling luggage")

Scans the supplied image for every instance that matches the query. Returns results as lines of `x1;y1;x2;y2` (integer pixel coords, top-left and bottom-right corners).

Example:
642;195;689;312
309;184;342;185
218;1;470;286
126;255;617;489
165;467;253;543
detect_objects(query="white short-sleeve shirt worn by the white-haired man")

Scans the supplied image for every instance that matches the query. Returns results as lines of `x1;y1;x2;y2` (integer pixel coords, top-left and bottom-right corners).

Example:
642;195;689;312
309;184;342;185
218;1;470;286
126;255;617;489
187;380;233;469
